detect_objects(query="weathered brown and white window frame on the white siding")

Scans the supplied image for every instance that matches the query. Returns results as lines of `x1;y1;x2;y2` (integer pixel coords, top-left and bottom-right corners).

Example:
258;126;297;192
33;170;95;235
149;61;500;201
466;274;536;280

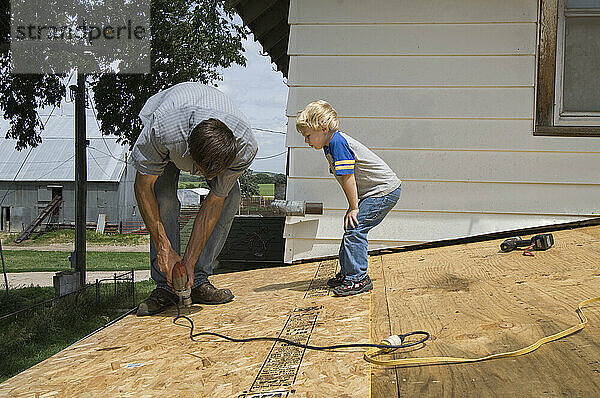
533;0;600;137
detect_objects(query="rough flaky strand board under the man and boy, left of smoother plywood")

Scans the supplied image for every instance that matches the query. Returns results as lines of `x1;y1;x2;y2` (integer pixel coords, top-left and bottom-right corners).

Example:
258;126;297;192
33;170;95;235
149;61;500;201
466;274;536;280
0;261;369;397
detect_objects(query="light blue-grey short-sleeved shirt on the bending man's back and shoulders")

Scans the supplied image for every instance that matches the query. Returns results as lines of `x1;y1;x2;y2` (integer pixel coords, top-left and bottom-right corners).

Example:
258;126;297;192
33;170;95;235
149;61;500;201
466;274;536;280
132;82;258;197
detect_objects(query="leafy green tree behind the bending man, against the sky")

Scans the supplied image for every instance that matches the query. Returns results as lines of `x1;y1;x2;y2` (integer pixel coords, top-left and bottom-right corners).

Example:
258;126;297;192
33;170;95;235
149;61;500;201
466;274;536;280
0;0;248;149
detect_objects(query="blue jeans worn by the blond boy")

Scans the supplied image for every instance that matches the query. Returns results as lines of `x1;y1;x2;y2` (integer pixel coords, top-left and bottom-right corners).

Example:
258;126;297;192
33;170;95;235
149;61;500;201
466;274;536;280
339;187;400;282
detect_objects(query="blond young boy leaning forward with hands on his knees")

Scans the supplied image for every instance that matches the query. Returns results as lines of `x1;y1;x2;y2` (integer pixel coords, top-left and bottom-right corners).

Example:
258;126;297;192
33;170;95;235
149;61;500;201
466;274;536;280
296;101;401;296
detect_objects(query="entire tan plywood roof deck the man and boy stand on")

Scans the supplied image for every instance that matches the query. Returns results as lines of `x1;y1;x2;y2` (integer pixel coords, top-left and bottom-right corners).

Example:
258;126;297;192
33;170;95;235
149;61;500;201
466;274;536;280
0;227;600;398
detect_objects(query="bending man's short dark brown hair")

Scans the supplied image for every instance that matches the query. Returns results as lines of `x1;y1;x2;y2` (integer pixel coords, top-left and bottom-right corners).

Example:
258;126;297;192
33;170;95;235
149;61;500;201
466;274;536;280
188;118;236;179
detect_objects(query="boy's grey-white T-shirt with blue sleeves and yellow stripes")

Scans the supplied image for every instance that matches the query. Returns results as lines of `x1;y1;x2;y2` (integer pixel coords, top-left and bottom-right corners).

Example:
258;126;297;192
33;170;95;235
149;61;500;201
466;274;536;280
323;131;401;199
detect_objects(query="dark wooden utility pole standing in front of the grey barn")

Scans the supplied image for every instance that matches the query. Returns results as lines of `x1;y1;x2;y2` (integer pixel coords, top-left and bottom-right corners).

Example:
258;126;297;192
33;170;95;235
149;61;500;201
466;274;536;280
71;72;87;287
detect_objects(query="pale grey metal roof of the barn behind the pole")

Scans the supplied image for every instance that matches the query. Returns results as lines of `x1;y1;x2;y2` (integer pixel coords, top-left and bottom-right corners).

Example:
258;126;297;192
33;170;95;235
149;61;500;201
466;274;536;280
0;103;128;182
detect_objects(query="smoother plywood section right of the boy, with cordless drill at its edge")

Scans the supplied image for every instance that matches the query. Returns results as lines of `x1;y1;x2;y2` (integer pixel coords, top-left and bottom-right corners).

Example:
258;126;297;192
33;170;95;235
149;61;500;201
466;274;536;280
373;227;600;397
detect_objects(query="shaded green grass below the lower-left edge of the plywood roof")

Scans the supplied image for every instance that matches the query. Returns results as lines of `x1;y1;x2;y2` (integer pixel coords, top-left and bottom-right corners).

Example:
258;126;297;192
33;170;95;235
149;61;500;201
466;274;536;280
0;281;155;383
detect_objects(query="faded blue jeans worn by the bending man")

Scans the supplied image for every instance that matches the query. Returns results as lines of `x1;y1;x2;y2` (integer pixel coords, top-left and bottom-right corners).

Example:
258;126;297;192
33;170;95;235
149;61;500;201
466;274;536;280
150;162;241;292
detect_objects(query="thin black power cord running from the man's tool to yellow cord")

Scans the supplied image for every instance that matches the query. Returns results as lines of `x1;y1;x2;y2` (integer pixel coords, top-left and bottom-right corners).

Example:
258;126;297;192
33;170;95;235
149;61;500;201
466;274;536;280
172;300;430;352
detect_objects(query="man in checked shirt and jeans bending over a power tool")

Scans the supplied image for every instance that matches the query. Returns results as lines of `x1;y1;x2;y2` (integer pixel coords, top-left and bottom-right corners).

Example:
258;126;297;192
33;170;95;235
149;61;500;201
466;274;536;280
131;82;258;316
